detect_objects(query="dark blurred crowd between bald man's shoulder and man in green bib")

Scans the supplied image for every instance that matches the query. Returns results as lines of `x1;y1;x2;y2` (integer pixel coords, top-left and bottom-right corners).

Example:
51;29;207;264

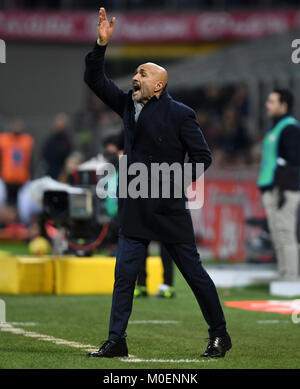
187;84;255;168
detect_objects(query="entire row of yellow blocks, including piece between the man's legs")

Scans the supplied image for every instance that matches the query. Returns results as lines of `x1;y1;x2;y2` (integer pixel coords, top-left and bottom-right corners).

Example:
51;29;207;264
0;257;163;295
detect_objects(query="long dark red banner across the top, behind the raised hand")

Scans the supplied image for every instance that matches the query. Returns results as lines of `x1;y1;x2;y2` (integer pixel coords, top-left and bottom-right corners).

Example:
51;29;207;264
0;10;300;43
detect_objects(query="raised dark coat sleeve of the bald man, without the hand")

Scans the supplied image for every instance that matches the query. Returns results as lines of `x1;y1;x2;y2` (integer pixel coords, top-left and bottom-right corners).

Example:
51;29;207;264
84;43;127;117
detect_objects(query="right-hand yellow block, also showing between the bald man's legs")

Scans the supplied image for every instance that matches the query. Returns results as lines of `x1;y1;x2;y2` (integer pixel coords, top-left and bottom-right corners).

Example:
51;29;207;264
55;257;163;295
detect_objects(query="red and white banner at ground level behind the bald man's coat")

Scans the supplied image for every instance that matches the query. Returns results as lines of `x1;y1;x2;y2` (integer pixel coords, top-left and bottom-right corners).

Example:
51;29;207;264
191;174;265;262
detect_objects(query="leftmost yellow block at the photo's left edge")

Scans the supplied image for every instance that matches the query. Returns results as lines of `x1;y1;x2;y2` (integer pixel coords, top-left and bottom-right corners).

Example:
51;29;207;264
0;257;54;294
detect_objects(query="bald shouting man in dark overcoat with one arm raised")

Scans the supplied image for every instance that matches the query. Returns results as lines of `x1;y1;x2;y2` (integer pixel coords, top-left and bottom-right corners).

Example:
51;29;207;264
85;8;231;357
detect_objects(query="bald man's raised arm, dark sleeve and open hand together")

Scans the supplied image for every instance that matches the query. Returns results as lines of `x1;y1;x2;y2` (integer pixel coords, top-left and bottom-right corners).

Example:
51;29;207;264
84;8;127;117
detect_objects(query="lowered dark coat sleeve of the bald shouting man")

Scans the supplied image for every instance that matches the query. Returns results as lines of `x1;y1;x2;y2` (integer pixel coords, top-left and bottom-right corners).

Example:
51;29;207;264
180;108;212;181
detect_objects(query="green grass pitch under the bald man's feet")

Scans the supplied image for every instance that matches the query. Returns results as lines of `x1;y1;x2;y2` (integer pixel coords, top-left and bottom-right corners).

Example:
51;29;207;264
0;266;300;369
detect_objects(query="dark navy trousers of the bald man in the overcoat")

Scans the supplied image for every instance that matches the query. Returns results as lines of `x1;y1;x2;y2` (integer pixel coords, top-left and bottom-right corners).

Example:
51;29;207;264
109;233;226;340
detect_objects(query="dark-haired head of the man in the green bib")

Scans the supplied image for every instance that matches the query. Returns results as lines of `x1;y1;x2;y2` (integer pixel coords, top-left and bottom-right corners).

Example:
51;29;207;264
266;88;294;118
